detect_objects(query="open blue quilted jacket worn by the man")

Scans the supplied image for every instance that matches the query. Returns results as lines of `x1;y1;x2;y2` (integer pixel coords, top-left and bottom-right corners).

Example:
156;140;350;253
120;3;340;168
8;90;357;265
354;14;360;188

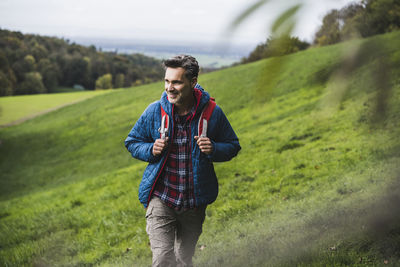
125;85;240;207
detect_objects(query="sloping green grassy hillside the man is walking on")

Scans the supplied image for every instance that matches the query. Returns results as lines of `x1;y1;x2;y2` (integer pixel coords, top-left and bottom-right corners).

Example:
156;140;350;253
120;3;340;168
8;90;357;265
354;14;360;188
0;30;400;266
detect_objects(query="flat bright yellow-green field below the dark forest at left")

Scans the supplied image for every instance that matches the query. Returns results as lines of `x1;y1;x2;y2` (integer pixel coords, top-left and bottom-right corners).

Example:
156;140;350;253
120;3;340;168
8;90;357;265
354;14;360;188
0;90;109;126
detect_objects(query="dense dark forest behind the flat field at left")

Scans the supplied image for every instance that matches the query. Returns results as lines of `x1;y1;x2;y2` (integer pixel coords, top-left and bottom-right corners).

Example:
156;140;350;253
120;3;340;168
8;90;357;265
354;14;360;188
0;29;163;96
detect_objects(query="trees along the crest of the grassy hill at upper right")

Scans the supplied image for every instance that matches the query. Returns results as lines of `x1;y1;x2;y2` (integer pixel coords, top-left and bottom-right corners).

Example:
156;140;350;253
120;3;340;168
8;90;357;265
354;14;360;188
240;0;400;63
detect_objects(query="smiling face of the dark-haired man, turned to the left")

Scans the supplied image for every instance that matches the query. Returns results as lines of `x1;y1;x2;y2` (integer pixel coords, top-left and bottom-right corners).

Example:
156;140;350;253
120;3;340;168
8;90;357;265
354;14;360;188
165;67;197;107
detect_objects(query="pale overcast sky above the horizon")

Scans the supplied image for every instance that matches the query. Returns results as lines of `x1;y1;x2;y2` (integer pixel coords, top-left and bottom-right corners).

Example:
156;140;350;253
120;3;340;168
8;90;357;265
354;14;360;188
0;0;351;47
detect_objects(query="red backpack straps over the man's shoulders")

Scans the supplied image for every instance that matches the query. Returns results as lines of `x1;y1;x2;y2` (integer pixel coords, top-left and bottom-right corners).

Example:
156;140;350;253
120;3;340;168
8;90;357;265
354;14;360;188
158;97;217;139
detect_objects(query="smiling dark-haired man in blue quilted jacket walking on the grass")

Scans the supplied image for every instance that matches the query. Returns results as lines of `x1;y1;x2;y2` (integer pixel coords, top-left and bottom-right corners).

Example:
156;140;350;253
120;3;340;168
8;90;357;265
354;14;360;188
125;55;240;267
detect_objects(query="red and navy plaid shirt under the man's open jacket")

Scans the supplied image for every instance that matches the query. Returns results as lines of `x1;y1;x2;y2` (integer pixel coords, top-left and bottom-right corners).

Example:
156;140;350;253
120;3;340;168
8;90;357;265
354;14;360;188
153;107;195;210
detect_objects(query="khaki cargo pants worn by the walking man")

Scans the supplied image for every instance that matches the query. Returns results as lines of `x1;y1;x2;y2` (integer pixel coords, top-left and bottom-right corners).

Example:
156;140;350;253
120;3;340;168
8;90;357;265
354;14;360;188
146;197;206;267
